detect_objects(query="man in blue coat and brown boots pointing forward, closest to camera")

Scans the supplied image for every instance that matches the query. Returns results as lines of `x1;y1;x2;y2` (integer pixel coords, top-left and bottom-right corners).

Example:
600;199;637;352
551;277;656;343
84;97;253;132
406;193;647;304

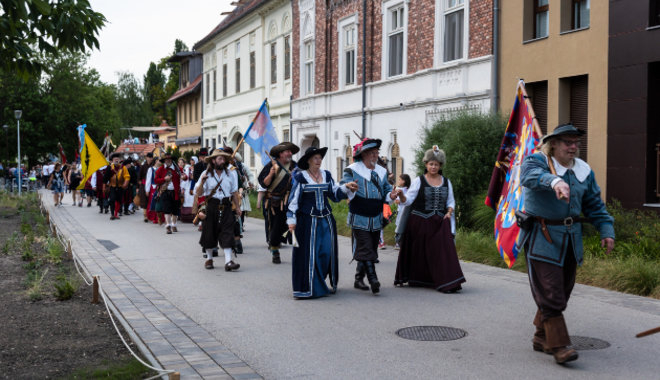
518;124;614;364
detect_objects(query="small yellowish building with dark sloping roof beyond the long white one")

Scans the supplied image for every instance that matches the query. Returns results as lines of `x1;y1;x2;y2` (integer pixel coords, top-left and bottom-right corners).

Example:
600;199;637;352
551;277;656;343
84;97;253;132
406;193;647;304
167;52;202;152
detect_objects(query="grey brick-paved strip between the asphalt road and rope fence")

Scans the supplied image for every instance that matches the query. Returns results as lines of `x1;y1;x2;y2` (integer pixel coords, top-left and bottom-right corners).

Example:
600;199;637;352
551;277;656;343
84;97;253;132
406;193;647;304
42;193;261;379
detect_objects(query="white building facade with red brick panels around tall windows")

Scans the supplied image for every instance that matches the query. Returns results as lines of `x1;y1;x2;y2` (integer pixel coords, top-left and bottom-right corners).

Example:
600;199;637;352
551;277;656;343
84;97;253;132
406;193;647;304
291;0;493;177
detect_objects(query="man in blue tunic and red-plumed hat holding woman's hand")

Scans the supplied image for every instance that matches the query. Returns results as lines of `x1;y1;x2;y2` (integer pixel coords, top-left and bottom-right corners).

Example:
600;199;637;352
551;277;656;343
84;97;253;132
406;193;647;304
340;138;405;294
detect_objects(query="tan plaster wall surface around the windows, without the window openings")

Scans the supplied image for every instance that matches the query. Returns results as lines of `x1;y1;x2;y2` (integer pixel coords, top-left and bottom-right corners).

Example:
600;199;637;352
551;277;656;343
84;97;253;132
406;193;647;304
499;0;609;193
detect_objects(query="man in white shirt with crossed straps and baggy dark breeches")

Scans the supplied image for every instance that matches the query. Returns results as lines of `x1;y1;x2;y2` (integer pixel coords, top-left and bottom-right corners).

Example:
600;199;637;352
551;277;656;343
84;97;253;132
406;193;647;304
196;149;241;272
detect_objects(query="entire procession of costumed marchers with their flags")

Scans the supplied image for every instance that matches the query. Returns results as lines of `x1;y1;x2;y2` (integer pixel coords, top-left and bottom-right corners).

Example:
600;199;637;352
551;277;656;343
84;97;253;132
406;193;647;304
24;85;628;364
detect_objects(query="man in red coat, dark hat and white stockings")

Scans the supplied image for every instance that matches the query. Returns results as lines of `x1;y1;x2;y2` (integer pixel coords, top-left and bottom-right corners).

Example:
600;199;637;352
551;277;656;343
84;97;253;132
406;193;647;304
154;153;181;234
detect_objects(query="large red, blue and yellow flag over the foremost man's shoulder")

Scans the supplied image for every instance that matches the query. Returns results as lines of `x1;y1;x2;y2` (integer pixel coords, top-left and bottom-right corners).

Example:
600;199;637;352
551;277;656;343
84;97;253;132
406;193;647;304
486;80;541;268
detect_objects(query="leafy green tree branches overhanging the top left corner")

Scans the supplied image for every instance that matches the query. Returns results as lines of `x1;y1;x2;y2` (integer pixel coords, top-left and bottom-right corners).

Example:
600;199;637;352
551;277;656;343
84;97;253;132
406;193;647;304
0;0;107;79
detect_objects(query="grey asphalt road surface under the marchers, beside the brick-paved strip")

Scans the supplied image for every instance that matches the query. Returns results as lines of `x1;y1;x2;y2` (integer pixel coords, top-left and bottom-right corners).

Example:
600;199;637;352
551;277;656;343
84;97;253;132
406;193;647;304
50;195;660;379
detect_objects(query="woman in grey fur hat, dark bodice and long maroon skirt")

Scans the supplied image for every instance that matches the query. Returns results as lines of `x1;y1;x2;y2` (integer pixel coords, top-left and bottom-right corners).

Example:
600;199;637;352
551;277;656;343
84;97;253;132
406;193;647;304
394;146;465;293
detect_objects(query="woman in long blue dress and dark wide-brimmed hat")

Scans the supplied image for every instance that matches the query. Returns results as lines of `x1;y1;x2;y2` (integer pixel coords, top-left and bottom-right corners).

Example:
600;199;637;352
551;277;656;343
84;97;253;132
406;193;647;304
287;147;354;298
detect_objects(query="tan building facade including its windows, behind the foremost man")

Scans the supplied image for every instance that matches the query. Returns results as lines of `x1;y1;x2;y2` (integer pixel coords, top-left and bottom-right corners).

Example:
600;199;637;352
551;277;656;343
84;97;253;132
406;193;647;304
498;0;611;196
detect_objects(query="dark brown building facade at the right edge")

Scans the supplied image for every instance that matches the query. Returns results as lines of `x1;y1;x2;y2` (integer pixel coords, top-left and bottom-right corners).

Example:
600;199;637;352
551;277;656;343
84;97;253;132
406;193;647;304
604;0;660;210
